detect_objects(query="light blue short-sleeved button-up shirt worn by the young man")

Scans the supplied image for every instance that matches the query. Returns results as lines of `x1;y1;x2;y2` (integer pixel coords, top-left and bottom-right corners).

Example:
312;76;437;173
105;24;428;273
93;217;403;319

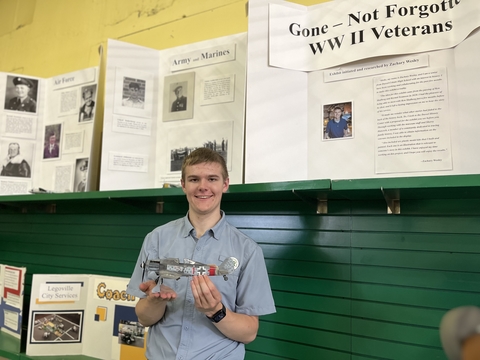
127;212;275;360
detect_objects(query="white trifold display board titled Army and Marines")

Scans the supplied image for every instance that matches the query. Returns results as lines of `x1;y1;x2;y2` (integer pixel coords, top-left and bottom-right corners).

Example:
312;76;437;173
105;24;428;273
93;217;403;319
100;34;247;190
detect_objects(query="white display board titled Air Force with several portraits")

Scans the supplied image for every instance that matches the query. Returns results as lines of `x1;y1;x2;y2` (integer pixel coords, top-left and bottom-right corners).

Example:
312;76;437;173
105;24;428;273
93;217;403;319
0;67;101;195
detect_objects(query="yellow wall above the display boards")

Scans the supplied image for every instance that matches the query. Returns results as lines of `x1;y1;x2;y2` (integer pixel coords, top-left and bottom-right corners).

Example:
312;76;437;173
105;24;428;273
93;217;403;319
0;0;325;78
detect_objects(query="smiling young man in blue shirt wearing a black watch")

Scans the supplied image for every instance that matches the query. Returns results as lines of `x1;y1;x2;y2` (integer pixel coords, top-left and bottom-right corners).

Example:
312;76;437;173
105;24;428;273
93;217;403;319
127;148;275;360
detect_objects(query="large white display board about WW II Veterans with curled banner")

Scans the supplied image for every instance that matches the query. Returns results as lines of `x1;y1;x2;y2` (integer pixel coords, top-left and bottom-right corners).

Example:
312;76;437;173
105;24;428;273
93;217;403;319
245;0;480;183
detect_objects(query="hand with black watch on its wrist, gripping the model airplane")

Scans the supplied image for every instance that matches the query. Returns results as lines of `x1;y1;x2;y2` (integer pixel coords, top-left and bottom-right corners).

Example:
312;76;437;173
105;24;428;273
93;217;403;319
191;275;222;316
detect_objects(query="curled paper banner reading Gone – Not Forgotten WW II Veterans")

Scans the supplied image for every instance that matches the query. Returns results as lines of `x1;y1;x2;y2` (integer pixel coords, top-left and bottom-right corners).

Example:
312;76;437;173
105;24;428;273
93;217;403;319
269;0;480;71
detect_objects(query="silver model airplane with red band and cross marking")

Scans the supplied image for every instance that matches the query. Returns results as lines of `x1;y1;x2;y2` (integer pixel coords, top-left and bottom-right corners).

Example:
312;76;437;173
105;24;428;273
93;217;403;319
141;257;238;283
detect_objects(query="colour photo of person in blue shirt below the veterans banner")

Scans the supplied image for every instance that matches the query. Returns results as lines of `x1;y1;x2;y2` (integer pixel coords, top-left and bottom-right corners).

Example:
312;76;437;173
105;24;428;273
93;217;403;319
322;101;353;140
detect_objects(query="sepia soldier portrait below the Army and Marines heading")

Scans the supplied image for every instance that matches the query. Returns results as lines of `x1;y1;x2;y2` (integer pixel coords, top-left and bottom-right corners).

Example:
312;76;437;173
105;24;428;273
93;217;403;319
163;72;195;121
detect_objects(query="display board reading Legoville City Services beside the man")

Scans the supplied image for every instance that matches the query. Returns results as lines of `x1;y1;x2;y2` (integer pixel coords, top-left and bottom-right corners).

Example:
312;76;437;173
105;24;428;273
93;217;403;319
27;274;147;360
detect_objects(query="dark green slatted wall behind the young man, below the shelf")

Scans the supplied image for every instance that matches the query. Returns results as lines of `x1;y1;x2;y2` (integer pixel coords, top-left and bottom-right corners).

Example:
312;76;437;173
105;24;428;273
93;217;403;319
0;181;480;360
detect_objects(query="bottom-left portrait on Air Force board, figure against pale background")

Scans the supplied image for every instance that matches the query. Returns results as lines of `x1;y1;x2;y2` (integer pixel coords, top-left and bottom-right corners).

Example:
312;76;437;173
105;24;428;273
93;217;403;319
0;140;34;178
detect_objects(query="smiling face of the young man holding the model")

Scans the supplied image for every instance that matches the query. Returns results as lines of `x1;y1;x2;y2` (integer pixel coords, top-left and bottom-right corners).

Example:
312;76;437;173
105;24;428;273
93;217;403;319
182;163;229;215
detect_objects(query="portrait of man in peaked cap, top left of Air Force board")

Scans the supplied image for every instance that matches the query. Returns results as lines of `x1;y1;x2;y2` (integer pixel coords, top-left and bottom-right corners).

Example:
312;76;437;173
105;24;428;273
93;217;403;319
5;75;38;113
